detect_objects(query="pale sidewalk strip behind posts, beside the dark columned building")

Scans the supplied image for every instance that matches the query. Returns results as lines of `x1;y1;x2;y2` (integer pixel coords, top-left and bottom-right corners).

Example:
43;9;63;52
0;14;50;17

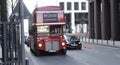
80;38;120;48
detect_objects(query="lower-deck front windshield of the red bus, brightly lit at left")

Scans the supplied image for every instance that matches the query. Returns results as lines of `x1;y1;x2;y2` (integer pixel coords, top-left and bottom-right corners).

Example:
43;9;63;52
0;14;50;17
37;25;63;36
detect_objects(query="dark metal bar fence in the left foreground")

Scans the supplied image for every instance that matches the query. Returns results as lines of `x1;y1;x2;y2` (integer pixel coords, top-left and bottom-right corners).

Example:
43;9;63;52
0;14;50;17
0;22;22;65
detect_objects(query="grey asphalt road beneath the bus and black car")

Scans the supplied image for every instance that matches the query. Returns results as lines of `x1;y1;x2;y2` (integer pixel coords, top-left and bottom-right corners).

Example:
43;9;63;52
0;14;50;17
26;45;120;65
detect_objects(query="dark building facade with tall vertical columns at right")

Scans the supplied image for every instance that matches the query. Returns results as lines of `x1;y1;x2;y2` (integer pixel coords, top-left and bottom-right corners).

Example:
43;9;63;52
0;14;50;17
88;0;120;40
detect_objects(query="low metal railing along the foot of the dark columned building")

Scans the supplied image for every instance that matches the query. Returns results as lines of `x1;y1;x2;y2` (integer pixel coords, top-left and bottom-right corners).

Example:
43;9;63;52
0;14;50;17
80;33;120;48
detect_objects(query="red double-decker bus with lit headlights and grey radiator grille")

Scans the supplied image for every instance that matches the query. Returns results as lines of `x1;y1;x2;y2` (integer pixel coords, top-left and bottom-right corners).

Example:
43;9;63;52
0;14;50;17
30;6;66;55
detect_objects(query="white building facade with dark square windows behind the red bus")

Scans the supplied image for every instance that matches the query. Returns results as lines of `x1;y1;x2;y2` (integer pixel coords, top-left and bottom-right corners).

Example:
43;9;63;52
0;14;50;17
57;0;88;33
